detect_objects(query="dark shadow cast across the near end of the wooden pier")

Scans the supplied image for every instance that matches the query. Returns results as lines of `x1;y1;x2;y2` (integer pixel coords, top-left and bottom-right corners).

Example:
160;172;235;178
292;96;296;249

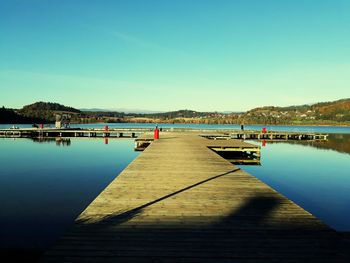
44;171;349;262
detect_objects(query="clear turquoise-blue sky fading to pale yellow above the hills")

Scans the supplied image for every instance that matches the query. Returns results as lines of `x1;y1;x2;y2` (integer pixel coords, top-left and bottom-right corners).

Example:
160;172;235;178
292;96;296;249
0;0;350;111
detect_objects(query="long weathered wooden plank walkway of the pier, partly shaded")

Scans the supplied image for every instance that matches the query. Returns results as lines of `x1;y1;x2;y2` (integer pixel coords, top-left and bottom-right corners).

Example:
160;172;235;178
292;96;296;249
43;133;345;262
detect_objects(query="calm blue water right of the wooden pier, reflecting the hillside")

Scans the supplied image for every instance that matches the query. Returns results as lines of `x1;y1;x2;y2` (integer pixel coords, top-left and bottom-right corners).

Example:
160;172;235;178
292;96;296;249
242;134;350;231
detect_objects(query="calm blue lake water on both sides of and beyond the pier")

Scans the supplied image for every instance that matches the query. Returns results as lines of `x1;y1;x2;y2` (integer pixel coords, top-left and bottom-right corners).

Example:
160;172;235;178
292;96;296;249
0;124;350;255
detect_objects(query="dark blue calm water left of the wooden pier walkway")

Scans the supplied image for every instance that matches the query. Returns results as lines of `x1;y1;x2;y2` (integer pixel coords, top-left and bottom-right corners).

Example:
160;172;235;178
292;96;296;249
0;138;139;253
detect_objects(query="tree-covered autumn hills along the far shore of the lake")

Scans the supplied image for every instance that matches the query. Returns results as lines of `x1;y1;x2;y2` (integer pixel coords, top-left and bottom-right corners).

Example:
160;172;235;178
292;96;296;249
0;99;350;125
